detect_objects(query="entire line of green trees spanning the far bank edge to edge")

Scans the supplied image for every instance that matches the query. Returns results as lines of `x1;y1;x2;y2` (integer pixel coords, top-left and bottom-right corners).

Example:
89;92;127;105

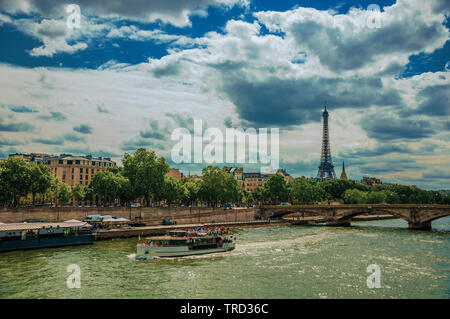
0;148;450;207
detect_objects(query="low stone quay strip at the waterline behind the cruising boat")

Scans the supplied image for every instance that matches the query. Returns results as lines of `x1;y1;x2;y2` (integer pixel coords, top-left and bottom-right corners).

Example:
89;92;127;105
95;220;291;240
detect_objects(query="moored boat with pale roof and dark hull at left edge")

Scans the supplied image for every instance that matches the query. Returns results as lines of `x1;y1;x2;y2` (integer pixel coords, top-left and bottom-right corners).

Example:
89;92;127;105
0;221;94;252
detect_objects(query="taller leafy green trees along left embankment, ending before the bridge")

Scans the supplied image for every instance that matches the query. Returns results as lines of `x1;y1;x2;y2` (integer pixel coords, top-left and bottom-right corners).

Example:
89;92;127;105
0;148;243;206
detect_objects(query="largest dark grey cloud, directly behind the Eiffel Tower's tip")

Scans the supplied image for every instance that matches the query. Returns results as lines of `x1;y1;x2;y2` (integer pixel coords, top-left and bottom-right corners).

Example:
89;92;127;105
219;72;403;126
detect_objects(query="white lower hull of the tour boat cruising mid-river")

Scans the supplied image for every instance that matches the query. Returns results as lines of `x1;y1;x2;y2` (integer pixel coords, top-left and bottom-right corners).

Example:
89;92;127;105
136;243;235;260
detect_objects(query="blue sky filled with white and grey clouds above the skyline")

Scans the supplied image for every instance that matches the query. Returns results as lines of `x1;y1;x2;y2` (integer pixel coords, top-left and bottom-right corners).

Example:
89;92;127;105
0;0;450;189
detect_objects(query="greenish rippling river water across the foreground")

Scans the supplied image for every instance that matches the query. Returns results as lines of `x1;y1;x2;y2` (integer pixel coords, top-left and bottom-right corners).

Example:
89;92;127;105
0;217;450;299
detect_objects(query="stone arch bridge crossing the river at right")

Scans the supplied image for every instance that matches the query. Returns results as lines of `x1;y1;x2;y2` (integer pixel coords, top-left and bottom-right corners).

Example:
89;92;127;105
258;204;450;230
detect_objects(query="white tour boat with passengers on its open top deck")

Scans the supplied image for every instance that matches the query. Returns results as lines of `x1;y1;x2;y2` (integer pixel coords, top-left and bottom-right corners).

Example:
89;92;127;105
136;227;236;260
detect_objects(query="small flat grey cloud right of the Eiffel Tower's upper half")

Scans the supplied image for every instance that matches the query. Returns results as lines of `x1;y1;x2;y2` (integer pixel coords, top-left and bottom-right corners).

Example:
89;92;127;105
361;115;437;141
